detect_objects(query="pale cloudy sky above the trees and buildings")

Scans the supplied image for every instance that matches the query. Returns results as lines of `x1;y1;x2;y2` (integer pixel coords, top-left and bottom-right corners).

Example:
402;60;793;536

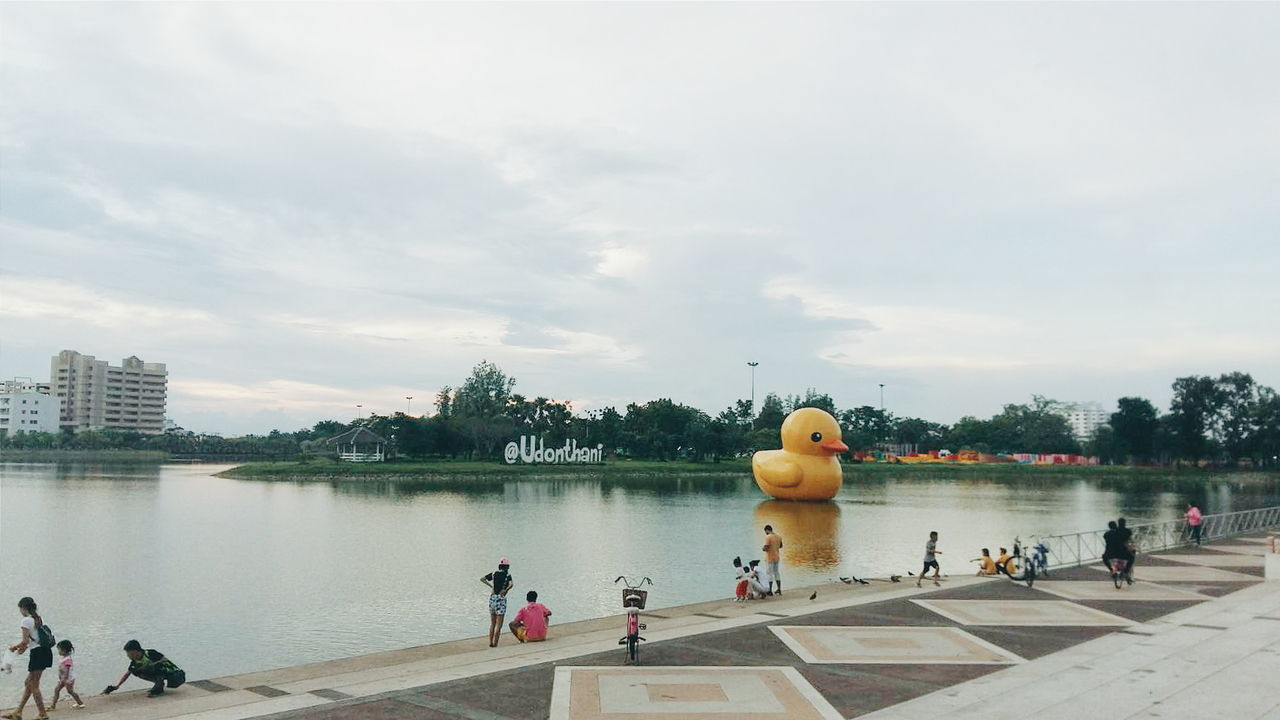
0;3;1280;433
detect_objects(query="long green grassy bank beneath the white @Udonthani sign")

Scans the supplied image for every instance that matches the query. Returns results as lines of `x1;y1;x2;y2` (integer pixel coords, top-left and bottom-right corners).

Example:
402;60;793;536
220;457;1280;482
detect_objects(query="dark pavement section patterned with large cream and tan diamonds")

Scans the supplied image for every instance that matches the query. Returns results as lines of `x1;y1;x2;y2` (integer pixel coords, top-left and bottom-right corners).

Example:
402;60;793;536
249;539;1265;720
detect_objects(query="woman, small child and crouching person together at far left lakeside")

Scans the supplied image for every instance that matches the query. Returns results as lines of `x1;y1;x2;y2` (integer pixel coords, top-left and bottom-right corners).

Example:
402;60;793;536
0;597;187;720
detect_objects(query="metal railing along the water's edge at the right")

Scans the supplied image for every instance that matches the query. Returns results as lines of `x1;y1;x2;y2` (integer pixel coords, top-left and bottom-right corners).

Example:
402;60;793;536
1039;506;1280;568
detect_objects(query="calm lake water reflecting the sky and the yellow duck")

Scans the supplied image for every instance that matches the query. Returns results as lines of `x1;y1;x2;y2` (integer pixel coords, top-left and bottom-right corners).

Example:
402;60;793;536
0;464;1280;693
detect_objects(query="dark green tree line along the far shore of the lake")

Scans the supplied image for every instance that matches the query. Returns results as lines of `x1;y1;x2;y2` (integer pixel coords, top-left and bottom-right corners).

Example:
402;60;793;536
0;361;1280;466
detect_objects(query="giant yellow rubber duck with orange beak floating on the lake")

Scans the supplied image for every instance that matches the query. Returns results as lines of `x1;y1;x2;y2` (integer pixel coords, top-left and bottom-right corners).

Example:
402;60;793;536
751;407;849;500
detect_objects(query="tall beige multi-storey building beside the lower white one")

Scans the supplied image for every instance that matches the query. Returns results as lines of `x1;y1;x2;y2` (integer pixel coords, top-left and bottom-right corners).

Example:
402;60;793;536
49;350;169;434
